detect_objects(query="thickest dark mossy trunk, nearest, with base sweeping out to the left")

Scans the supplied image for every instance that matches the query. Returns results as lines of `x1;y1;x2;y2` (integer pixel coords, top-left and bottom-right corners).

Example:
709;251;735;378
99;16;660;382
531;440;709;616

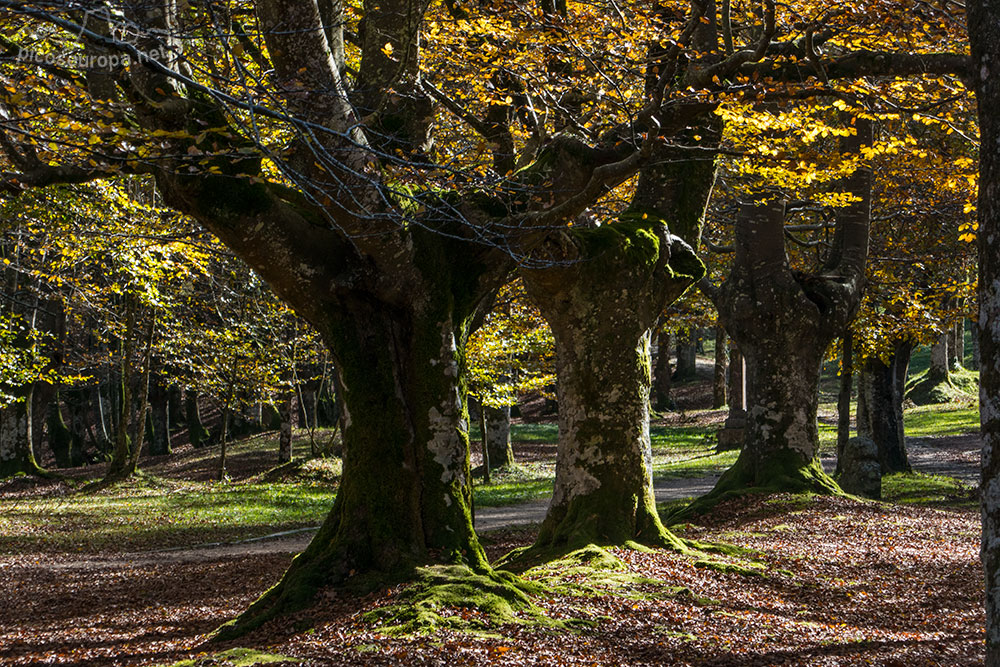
222;294;490;636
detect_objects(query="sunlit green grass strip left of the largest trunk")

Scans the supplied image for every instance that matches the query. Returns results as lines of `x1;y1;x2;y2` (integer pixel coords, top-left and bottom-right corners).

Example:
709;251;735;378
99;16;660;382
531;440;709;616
0;476;334;553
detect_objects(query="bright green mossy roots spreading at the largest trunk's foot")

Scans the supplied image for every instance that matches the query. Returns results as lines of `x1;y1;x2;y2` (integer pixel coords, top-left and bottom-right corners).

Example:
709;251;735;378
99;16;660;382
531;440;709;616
364;565;543;634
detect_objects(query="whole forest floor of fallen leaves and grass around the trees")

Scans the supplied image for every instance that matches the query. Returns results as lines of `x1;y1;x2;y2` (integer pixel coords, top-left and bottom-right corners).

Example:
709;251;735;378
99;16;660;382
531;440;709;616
0;368;984;667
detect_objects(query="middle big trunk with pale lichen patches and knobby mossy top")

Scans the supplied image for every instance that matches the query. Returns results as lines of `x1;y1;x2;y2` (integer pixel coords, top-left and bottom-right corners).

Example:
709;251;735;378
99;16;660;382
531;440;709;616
522;222;704;548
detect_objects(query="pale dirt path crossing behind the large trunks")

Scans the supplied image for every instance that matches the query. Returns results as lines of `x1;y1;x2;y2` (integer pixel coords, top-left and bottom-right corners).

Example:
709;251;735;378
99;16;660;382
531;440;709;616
27;434;979;570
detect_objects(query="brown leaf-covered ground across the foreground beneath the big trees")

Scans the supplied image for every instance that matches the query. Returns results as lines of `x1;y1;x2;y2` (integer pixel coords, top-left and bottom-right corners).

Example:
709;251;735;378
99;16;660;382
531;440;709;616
0;497;983;666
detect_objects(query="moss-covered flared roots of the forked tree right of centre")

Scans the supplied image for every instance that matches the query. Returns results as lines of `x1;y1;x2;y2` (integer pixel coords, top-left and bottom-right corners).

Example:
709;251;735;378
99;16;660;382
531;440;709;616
665;450;846;525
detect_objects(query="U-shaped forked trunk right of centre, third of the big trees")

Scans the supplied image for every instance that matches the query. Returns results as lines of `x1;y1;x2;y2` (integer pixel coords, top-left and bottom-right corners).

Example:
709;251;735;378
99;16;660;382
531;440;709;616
693;120;872;504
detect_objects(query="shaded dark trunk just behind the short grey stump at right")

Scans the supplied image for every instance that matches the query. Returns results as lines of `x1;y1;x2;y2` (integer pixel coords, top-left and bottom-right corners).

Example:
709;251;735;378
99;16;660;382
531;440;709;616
857;341;913;475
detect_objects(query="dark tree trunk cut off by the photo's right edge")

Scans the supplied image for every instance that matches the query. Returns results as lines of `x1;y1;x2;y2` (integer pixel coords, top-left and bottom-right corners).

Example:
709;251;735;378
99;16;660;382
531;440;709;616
966;6;1000;667
